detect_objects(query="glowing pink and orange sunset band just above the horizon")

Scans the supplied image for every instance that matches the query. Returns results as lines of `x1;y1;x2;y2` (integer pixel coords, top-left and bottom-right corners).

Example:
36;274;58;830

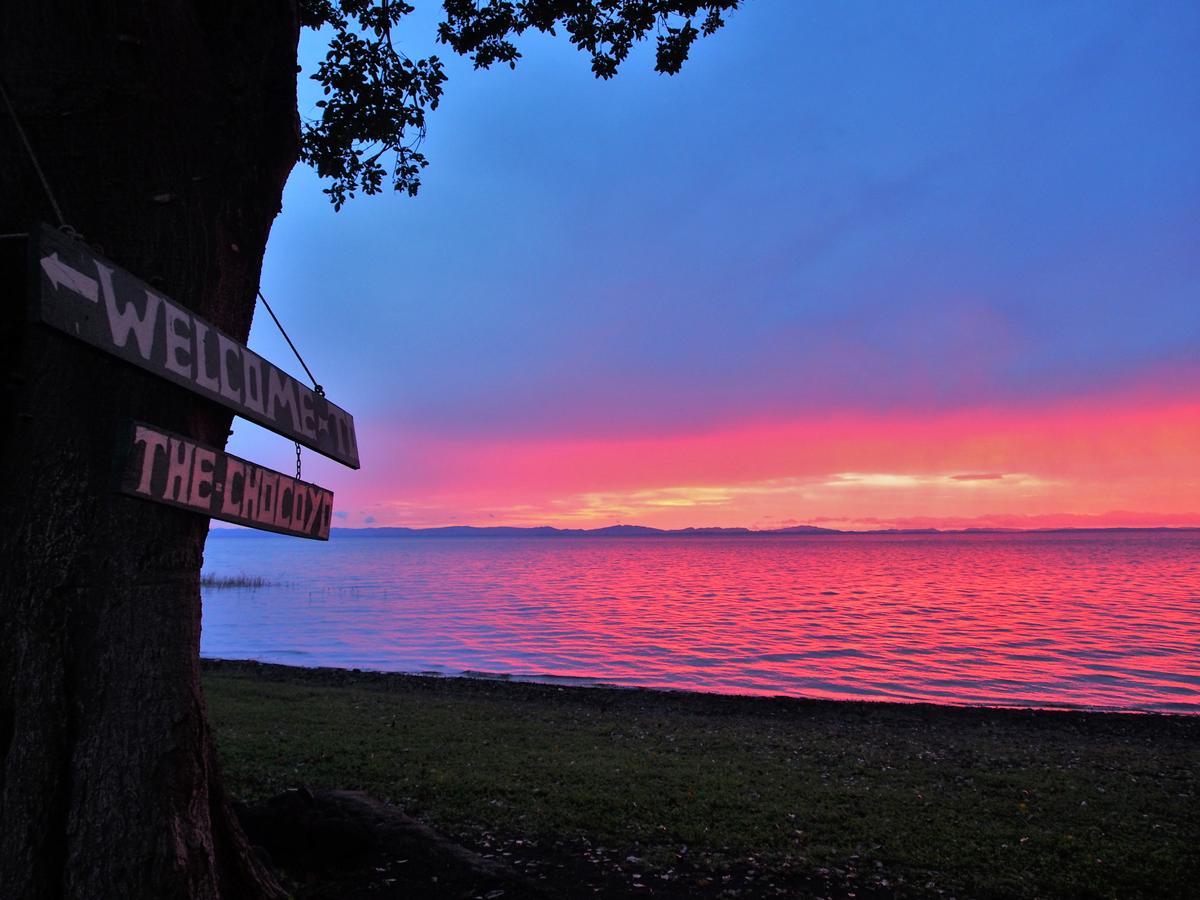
312;386;1200;529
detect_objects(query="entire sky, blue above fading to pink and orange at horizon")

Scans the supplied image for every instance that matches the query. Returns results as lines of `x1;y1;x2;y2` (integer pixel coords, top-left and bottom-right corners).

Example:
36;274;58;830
229;0;1200;529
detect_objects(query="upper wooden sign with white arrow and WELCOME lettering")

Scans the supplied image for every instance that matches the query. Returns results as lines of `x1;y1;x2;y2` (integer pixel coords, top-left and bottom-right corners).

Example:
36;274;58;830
30;224;359;469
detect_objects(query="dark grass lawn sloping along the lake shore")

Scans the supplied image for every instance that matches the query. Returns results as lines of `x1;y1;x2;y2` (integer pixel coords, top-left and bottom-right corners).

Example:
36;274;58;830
204;662;1200;898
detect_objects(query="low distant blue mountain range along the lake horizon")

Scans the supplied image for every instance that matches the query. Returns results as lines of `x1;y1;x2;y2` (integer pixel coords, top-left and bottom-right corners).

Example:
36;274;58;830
214;526;1200;538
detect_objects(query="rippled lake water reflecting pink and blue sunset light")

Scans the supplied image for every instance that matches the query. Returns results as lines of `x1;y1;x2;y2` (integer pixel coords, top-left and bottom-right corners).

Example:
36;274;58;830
202;530;1200;713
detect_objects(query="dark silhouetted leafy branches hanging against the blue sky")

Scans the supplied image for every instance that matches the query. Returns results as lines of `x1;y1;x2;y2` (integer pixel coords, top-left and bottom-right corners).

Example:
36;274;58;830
301;0;740;209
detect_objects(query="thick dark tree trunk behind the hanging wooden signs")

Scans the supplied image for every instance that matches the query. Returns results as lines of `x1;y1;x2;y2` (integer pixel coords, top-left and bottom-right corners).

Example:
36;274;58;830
0;0;299;899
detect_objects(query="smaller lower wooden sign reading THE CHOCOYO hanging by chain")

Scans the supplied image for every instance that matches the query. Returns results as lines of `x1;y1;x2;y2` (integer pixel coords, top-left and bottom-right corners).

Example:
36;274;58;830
120;422;334;541
